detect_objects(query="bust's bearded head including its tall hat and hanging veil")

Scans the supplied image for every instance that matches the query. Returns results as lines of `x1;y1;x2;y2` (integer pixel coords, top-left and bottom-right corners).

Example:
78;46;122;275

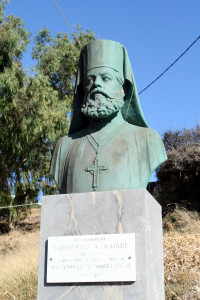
69;40;148;133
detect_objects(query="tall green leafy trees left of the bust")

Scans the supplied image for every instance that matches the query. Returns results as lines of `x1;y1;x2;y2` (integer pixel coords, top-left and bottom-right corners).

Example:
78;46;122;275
0;0;94;228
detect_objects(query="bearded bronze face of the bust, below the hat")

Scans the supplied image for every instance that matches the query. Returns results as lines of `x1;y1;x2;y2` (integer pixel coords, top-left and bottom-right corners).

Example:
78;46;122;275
81;67;124;118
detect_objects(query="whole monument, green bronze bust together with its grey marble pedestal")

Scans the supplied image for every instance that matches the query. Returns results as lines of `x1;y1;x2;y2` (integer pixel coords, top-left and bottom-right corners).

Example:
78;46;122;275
38;40;166;300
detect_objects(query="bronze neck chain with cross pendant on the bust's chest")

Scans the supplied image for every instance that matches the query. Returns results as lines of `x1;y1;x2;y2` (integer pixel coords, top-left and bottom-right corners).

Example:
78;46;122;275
85;122;126;191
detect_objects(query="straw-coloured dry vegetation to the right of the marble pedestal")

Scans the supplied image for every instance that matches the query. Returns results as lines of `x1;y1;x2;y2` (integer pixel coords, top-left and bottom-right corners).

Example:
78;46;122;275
164;209;200;300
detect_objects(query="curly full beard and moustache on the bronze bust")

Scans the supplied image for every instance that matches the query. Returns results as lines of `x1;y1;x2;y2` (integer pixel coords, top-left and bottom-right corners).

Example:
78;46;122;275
81;89;124;118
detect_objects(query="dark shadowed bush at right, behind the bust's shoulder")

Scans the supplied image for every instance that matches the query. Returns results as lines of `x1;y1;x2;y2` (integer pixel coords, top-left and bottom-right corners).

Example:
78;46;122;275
156;124;200;211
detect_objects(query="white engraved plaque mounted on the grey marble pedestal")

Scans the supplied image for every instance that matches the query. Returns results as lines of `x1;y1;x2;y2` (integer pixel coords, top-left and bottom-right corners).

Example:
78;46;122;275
47;233;136;283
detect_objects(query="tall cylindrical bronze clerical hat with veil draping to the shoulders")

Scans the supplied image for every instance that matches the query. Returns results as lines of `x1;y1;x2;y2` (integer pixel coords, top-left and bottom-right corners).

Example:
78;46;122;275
69;40;148;134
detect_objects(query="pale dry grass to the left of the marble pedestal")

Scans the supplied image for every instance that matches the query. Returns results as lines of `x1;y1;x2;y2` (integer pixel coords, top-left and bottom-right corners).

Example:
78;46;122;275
0;210;39;300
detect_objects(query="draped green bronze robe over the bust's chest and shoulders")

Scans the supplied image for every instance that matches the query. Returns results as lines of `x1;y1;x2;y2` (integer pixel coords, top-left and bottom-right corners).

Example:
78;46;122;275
50;122;167;194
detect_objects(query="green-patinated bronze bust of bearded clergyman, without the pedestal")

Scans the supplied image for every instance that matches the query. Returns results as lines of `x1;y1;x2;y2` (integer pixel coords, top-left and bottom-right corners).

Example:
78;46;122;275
50;40;167;194
